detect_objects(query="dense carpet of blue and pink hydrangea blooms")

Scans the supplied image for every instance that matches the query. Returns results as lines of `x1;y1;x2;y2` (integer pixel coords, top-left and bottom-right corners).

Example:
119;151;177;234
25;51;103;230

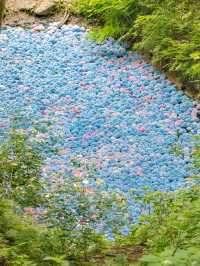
0;25;200;220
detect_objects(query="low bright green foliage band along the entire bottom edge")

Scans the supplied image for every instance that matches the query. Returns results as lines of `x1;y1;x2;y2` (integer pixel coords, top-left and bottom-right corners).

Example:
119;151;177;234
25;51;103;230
0;186;200;266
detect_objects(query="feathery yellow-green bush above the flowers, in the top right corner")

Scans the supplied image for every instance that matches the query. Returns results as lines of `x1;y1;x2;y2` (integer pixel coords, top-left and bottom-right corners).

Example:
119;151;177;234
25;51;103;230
75;0;200;89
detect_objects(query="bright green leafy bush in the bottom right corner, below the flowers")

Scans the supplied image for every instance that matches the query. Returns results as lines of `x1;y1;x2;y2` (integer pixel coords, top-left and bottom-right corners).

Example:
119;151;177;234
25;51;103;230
123;185;200;266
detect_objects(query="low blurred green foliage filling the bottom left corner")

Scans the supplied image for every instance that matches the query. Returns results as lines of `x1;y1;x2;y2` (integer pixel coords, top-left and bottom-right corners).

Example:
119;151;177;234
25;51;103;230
0;196;117;266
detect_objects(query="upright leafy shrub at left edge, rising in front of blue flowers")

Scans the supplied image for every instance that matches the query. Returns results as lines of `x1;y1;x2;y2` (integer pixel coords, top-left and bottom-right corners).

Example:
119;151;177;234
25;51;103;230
0;131;43;206
